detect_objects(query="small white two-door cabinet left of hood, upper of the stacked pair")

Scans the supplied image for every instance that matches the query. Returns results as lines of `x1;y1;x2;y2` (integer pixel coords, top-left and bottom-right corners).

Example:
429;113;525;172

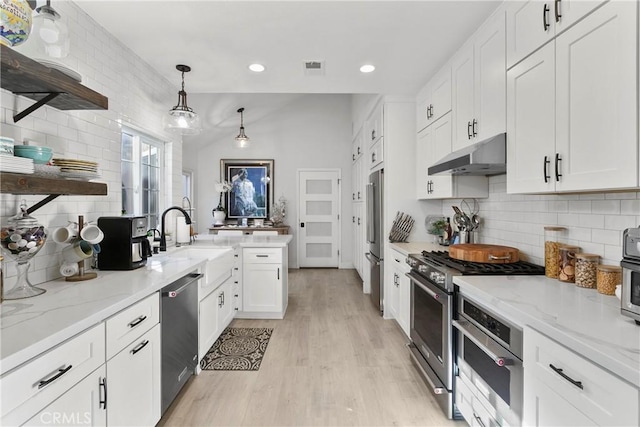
416;64;451;132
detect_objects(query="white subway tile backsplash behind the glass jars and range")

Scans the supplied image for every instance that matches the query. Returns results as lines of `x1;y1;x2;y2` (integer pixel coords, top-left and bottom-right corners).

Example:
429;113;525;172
450;175;640;265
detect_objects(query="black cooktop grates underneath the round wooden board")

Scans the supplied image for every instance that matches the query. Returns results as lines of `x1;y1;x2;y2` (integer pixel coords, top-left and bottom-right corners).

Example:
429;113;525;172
422;251;544;275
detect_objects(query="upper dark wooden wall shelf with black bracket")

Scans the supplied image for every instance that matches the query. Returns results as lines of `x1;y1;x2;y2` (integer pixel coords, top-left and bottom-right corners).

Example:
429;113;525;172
0;45;109;122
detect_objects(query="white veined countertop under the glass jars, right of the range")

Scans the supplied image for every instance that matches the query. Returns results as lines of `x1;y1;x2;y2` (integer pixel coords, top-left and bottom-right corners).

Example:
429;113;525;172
453;276;640;387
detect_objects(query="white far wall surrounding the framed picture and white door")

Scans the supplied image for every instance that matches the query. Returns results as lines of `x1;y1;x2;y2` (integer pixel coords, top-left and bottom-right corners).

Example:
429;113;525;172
183;94;351;268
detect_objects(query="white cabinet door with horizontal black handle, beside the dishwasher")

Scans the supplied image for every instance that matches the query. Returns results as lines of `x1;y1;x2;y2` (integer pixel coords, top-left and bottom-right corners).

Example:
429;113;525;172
106;324;161;426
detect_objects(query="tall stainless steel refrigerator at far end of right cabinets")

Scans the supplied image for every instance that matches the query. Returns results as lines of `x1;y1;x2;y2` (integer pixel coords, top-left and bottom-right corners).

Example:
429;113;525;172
366;169;384;315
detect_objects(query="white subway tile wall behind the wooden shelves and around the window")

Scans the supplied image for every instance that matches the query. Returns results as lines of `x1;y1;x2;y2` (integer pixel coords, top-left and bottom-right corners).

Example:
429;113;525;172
0;1;182;288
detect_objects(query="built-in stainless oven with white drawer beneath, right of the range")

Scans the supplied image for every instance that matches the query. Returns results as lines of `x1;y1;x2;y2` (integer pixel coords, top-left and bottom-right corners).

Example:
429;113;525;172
452;294;523;427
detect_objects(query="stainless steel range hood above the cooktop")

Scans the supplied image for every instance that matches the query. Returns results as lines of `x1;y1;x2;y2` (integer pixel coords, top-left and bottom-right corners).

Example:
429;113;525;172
428;133;507;176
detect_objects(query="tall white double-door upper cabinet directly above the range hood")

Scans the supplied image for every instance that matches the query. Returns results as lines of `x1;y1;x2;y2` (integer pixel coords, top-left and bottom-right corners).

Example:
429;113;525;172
452;9;506;151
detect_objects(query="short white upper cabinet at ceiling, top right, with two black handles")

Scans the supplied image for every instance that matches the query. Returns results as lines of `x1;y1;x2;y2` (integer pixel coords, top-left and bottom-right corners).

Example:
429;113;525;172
507;0;607;68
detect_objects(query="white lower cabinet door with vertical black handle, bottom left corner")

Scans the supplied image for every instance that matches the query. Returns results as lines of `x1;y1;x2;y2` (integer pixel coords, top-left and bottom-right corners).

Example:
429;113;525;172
25;365;106;426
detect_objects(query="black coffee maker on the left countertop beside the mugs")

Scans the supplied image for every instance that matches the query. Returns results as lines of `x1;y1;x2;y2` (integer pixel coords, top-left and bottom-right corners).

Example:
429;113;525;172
98;216;151;270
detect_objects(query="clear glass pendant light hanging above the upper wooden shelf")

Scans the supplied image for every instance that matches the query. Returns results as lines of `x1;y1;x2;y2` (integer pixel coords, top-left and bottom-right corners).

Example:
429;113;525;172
25;0;70;59
